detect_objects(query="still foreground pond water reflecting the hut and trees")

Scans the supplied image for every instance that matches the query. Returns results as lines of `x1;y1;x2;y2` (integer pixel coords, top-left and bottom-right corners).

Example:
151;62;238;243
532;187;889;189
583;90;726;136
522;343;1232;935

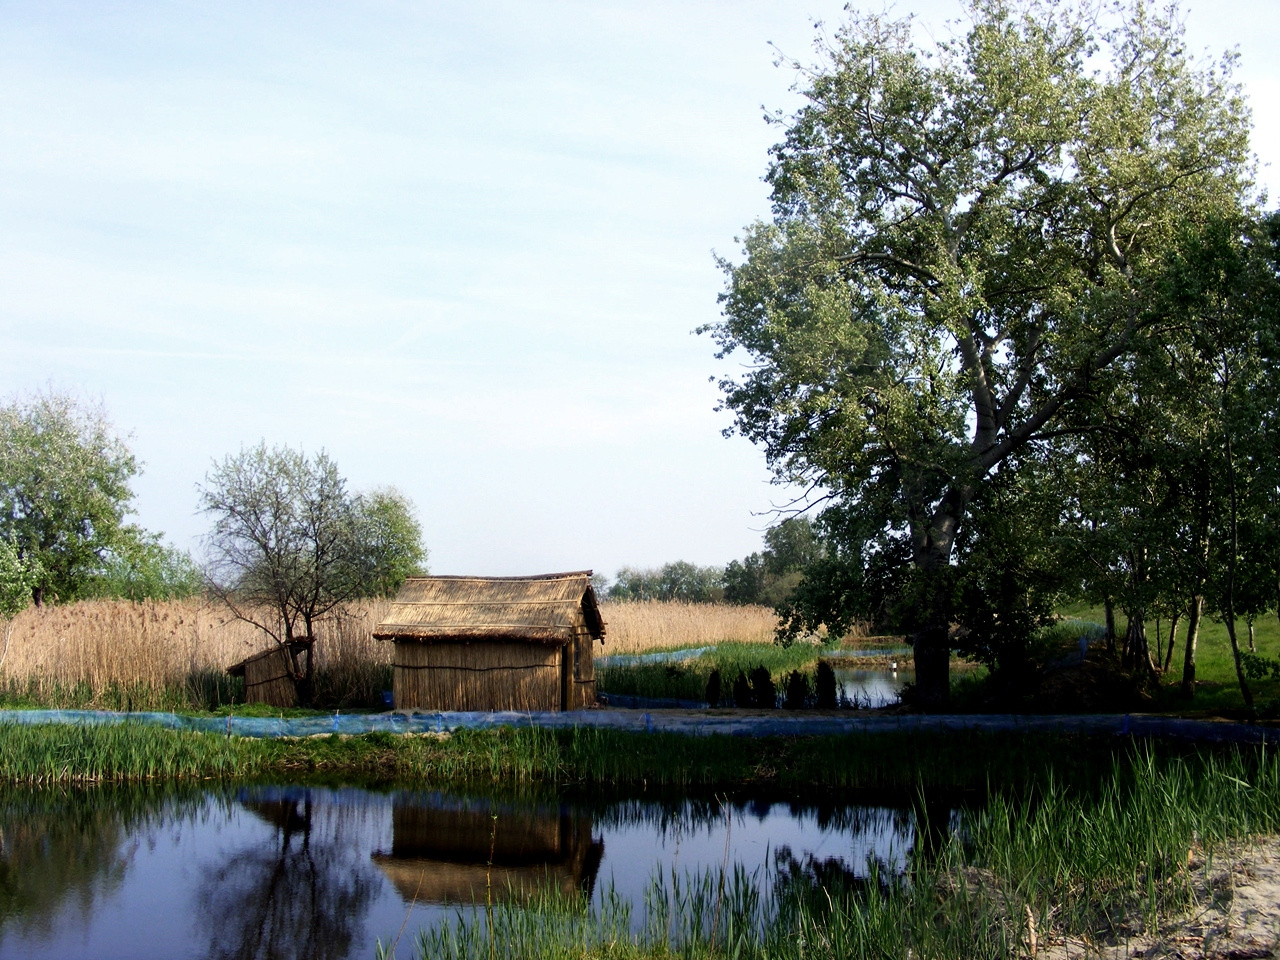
0;786;950;960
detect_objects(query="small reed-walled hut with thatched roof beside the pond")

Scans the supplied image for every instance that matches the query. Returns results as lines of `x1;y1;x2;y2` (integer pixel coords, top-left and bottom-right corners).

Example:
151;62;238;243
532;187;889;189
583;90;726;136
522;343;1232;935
374;571;604;710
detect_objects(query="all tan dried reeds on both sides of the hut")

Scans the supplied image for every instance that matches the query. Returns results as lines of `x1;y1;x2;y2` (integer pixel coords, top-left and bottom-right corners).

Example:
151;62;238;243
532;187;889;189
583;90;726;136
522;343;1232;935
0;599;777;709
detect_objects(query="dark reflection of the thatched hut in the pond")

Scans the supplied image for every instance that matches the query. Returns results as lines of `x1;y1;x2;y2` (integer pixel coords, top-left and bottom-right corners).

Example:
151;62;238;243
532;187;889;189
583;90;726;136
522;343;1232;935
372;801;604;904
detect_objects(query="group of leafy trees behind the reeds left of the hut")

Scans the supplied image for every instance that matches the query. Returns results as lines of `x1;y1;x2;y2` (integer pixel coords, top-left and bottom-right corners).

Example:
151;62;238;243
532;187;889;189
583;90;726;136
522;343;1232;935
0;390;426;643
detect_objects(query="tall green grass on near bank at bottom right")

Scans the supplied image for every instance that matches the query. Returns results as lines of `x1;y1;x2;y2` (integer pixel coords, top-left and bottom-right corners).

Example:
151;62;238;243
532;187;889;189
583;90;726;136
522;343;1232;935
409;750;1280;960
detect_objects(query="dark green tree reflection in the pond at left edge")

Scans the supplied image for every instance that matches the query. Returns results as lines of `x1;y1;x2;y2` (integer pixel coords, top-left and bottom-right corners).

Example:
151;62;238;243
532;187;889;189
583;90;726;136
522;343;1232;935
0;787;198;943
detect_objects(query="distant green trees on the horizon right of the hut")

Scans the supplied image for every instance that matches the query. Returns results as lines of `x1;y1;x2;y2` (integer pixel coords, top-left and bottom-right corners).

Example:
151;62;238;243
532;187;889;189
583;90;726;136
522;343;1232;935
598;517;826;607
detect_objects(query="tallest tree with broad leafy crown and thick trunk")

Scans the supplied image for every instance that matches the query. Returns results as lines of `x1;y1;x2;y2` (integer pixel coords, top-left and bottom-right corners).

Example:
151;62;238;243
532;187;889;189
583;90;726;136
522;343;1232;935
709;0;1251;708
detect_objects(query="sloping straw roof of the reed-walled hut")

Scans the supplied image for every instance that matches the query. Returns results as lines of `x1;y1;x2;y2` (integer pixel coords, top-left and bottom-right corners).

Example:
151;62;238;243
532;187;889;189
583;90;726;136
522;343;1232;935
374;570;604;644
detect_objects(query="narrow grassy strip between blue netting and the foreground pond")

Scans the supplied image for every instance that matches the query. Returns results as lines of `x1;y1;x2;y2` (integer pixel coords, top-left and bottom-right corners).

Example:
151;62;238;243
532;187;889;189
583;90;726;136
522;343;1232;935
0;723;1249;792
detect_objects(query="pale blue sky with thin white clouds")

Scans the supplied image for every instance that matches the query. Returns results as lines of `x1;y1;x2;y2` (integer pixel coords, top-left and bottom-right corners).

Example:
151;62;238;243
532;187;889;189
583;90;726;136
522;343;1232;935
0;0;1280;575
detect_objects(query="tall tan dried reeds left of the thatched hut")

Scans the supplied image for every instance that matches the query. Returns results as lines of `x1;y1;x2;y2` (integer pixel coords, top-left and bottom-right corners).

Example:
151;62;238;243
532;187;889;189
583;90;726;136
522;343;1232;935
0;600;392;709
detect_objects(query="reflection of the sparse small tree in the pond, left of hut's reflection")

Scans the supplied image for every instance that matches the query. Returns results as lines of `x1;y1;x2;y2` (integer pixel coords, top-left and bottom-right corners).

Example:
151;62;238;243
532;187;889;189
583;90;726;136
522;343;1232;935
197;792;380;960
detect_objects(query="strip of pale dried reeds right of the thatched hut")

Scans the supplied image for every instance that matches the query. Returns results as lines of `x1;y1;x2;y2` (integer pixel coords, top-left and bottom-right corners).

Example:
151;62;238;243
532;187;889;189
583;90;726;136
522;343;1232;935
600;600;778;654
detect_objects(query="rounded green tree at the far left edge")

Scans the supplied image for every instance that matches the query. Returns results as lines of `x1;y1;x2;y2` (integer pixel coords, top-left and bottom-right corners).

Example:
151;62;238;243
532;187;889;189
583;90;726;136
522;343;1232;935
0;393;138;603
